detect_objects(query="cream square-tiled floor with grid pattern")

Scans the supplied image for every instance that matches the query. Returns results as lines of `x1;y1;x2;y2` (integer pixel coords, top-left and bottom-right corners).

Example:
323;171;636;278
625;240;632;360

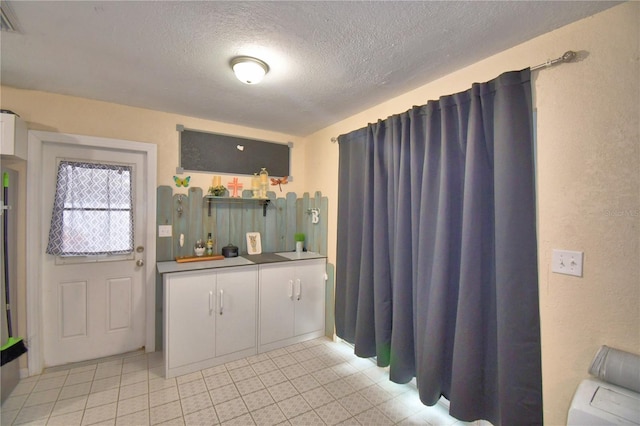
2;338;484;426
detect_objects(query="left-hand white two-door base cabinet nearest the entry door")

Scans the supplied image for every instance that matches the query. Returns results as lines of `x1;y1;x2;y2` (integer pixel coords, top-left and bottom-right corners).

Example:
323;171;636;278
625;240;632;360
164;266;258;378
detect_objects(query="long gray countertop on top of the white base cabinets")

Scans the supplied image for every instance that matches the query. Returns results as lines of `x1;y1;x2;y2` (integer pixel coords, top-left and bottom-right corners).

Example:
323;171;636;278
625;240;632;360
156;251;327;274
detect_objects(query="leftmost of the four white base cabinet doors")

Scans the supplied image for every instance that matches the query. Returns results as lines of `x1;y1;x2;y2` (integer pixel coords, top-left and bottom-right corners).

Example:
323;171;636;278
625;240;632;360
165;273;216;368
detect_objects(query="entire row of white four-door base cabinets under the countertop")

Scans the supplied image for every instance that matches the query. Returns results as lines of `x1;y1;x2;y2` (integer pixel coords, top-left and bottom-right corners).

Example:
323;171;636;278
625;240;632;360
163;258;326;378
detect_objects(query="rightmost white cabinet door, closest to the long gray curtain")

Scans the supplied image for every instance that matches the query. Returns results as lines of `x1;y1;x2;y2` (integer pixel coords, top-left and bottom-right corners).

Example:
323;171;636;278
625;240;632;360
294;259;326;336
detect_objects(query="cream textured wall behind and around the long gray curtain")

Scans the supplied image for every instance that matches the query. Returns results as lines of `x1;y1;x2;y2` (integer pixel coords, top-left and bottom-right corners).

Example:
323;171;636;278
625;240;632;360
306;2;640;425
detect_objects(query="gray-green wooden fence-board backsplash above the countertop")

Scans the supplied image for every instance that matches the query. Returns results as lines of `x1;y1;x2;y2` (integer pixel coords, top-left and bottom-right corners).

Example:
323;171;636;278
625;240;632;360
156;186;329;262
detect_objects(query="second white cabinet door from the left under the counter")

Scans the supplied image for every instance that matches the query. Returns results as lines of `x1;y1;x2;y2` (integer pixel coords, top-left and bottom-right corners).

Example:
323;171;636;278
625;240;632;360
216;267;258;356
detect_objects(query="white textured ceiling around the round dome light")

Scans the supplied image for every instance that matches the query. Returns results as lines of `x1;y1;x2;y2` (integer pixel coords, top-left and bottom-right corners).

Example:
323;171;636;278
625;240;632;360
0;1;617;136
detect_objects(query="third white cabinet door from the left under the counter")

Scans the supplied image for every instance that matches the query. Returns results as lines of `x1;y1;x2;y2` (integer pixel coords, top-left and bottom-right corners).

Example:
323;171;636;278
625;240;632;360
260;265;294;345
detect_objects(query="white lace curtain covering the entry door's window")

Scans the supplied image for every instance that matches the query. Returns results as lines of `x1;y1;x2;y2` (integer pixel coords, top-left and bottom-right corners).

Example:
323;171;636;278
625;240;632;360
47;161;133;256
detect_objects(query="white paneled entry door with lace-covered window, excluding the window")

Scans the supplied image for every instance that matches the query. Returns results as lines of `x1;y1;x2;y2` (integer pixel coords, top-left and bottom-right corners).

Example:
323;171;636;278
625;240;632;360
41;143;151;366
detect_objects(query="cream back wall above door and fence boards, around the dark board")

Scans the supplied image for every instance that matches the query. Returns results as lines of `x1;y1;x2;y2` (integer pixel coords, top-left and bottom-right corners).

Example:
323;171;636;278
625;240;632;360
0;90;305;193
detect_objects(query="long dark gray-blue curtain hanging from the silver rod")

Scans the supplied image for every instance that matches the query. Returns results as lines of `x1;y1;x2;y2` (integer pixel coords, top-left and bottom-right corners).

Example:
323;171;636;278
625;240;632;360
335;69;542;425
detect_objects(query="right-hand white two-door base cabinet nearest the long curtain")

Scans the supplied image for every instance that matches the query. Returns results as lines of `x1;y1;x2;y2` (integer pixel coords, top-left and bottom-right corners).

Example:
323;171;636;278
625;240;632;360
258;259;326;352
